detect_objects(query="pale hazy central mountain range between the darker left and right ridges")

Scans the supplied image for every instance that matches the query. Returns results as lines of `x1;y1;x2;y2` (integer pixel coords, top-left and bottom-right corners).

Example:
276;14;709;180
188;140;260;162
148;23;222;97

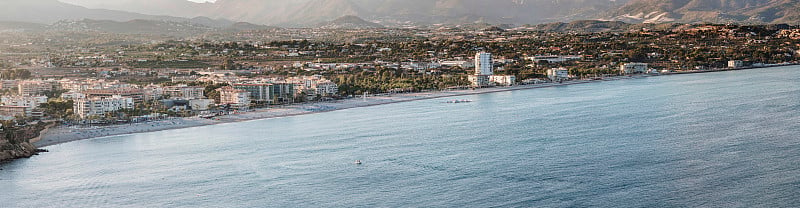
54;0;627;27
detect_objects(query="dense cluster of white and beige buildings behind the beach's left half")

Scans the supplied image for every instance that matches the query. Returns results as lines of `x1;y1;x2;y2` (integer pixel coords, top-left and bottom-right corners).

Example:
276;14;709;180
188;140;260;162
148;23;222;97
0;74;338;120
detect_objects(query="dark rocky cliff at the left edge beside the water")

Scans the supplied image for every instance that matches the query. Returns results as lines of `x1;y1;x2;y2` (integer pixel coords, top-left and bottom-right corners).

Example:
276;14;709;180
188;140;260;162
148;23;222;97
0;123;52;161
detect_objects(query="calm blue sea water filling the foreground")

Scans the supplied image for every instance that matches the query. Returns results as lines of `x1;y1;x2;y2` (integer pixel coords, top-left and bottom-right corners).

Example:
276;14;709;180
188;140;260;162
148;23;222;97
0;67;800;207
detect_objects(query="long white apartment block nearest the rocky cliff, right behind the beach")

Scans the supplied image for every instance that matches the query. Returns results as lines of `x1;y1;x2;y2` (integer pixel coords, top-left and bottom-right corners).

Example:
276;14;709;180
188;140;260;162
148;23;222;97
72;96;134;118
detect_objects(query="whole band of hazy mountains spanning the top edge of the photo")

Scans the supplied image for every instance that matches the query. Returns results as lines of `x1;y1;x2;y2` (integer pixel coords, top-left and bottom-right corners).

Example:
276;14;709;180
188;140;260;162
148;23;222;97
0;0;800;28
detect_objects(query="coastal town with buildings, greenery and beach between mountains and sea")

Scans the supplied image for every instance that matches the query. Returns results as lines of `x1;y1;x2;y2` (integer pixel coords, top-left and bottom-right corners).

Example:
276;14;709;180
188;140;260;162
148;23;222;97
0;21;800;161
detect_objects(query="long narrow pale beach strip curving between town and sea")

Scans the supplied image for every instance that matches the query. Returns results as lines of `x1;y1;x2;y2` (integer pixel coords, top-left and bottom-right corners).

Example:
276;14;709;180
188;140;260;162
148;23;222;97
32;64;796;148
